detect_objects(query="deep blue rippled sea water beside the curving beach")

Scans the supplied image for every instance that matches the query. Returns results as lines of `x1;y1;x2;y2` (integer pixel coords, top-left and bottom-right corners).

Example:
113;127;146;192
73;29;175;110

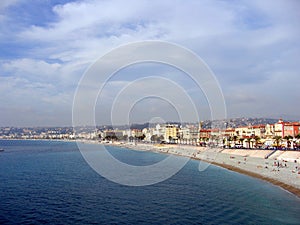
0;140;300;224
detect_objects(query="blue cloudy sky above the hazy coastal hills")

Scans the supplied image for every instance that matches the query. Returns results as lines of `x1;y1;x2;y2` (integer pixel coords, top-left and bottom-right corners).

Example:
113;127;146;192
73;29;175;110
0;0;300;127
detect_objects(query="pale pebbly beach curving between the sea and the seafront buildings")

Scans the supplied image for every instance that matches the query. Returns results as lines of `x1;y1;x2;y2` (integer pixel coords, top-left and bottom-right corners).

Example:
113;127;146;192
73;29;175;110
101;143;300;197
